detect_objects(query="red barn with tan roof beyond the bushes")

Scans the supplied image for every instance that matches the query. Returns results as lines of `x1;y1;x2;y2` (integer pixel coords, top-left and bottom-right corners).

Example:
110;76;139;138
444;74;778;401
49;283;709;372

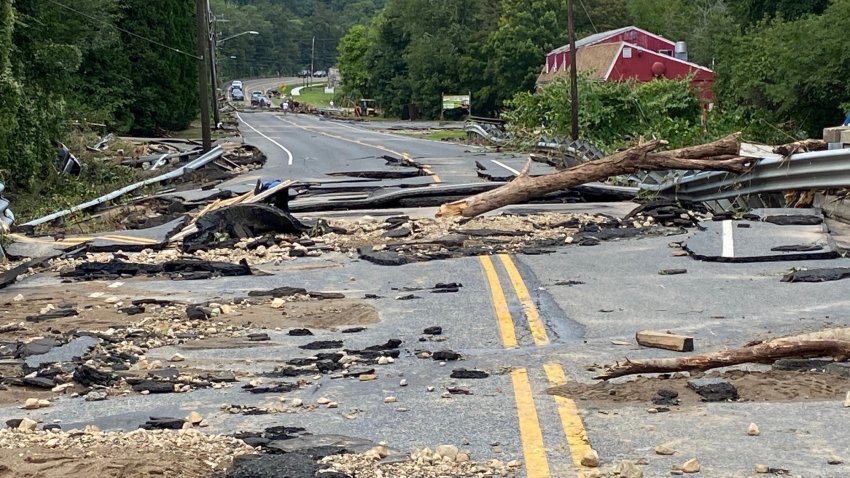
537;27;714;101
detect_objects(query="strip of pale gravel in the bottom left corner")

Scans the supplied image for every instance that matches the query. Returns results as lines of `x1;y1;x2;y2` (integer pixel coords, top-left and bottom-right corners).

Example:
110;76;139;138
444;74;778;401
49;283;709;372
0;426;255;471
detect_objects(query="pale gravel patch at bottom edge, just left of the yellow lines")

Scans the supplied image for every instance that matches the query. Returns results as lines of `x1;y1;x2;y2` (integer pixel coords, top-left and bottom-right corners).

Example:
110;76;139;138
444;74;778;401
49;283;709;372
320;445;522;478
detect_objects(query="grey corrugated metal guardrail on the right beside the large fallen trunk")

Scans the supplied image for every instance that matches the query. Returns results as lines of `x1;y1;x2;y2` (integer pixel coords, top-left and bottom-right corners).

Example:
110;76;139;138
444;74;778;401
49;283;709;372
641;149;850;202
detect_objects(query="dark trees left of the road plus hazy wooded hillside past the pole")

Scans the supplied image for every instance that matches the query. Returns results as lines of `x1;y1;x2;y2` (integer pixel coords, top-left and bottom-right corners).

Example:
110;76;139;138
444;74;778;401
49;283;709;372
0;0;383;191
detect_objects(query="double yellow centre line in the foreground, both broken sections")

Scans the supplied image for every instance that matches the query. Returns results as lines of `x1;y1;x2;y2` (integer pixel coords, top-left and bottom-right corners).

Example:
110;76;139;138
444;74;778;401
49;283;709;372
479;254;591;478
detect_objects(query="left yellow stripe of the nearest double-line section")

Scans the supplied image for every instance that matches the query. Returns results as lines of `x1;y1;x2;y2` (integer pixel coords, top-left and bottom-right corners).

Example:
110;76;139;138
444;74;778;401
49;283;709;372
511;368;551;478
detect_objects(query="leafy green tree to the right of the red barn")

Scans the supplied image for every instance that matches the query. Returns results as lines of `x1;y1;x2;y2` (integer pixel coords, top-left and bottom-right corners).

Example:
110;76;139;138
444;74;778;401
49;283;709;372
715;0;850;140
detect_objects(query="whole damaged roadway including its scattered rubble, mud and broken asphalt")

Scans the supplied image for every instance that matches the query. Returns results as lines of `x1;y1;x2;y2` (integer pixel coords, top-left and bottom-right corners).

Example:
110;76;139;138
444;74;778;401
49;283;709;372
0;109;850;477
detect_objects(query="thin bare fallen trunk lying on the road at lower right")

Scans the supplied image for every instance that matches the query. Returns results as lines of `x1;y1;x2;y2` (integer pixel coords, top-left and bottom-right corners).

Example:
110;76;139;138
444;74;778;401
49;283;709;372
594;339;850;380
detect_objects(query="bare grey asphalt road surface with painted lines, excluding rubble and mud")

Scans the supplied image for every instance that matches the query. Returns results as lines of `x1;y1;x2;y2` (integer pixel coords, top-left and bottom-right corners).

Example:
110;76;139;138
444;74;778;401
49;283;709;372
0;108;850;478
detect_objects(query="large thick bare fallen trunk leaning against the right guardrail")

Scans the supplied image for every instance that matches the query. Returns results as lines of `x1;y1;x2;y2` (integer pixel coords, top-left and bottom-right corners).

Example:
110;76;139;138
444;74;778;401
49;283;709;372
437;134;755;217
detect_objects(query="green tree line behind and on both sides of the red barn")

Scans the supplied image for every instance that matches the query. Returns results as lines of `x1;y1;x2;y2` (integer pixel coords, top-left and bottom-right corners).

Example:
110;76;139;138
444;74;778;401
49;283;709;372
338;0;850;140
